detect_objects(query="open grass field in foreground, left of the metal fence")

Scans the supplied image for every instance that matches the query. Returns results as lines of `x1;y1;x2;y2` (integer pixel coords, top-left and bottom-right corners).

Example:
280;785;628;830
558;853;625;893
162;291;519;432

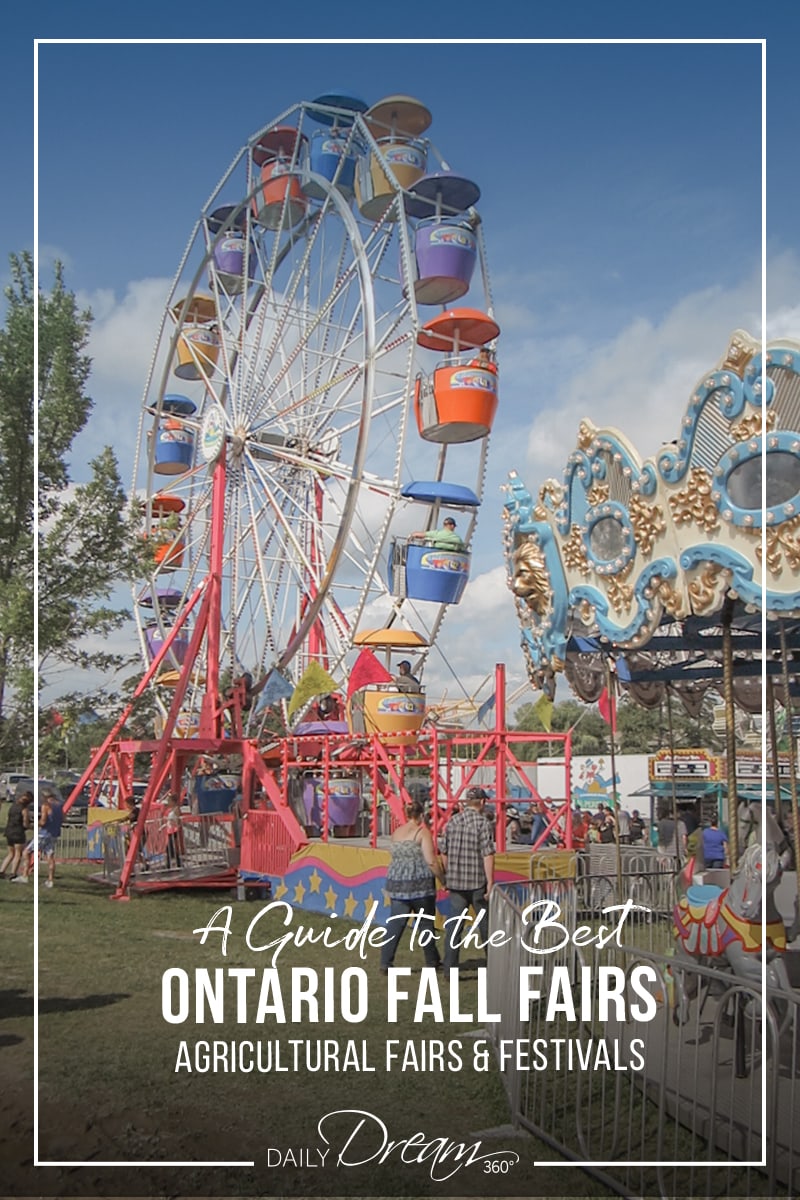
0;865;610;1196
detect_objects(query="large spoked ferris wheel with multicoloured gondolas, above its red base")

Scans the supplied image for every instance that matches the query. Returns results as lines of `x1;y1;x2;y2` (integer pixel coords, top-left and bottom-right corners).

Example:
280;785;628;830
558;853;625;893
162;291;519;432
134;95;498;734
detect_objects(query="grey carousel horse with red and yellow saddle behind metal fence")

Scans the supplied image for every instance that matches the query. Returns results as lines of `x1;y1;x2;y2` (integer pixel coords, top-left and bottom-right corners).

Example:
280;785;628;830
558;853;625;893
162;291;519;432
672;822;798;1025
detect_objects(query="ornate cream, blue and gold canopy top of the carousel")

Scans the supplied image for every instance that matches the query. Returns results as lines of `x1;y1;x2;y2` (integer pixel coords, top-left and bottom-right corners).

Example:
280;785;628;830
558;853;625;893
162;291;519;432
504;330;800;712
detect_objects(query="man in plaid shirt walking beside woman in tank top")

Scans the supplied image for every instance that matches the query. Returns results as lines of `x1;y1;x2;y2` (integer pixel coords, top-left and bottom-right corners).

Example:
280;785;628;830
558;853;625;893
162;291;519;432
440;787;494;970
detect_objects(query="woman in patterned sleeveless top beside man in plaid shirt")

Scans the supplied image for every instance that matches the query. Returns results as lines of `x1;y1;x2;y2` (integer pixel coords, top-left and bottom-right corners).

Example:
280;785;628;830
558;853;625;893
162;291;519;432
380;800;444;974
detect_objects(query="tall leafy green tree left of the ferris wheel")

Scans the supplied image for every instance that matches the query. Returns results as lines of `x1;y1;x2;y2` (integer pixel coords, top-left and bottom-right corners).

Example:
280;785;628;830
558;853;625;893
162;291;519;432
0;253;143;758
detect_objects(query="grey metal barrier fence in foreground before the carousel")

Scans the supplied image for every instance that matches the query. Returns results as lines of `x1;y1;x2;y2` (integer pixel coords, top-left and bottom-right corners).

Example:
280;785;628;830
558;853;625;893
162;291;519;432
488;877;800;1200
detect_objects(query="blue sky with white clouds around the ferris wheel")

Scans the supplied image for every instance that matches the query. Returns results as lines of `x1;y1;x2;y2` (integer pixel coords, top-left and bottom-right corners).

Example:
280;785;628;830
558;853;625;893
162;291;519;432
7;21;800;710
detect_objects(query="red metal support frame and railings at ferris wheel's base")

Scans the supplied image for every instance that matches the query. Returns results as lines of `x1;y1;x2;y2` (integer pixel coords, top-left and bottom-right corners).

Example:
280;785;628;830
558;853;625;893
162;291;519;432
65;405;572;900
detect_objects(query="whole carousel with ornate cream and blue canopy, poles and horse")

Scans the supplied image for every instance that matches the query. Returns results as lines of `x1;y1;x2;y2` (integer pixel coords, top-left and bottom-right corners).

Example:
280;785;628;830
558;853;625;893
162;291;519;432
505;331;800;988
